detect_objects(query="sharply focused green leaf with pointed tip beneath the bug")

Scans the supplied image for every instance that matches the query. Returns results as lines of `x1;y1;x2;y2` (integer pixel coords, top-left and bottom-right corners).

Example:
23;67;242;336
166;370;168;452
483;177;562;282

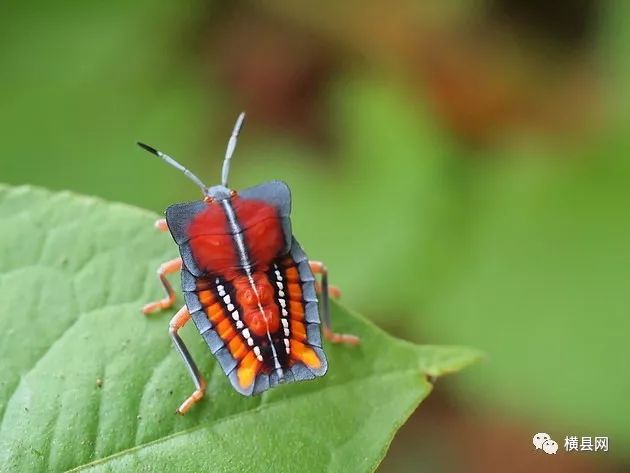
0;186;479;471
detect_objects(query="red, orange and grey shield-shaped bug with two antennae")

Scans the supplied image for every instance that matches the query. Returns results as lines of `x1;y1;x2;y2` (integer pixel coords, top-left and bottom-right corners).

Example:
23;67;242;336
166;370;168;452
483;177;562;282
138;113;359;415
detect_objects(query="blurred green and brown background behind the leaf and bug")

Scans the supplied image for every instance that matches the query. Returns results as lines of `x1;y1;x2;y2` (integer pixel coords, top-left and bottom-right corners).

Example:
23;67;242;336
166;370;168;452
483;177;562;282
0;0;630;472
